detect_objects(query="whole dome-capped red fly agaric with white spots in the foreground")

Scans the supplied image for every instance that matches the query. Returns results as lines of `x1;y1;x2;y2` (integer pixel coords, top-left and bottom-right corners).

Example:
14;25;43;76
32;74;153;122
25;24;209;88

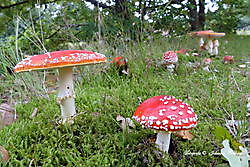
133;95;197;152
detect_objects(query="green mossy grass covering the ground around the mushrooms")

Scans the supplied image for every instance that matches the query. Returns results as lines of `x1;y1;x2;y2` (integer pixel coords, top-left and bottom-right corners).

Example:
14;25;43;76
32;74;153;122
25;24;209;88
0;36;250;167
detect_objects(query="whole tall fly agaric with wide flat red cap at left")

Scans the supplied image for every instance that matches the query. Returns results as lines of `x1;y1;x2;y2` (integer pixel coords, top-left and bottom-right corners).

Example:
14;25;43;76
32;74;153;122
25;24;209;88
14;50;107;123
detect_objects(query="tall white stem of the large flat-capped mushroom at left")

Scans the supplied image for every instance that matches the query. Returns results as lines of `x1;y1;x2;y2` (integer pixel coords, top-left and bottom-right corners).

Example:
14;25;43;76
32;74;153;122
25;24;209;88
57;67;76;123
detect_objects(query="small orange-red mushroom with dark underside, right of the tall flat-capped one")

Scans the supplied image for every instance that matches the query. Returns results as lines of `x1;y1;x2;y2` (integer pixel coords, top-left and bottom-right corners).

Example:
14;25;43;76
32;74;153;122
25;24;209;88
111;56;129;75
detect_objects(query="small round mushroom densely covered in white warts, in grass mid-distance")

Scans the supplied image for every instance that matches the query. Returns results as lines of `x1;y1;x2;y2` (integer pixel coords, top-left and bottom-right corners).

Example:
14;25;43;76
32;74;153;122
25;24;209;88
162;51;178;72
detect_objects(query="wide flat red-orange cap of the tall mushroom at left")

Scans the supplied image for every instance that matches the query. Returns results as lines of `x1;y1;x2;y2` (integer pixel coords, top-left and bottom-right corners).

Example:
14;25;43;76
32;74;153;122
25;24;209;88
14;50;107;72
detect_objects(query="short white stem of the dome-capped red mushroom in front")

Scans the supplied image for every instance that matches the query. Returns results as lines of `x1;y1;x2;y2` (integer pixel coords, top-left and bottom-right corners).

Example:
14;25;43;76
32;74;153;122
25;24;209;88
155;132;171;152
